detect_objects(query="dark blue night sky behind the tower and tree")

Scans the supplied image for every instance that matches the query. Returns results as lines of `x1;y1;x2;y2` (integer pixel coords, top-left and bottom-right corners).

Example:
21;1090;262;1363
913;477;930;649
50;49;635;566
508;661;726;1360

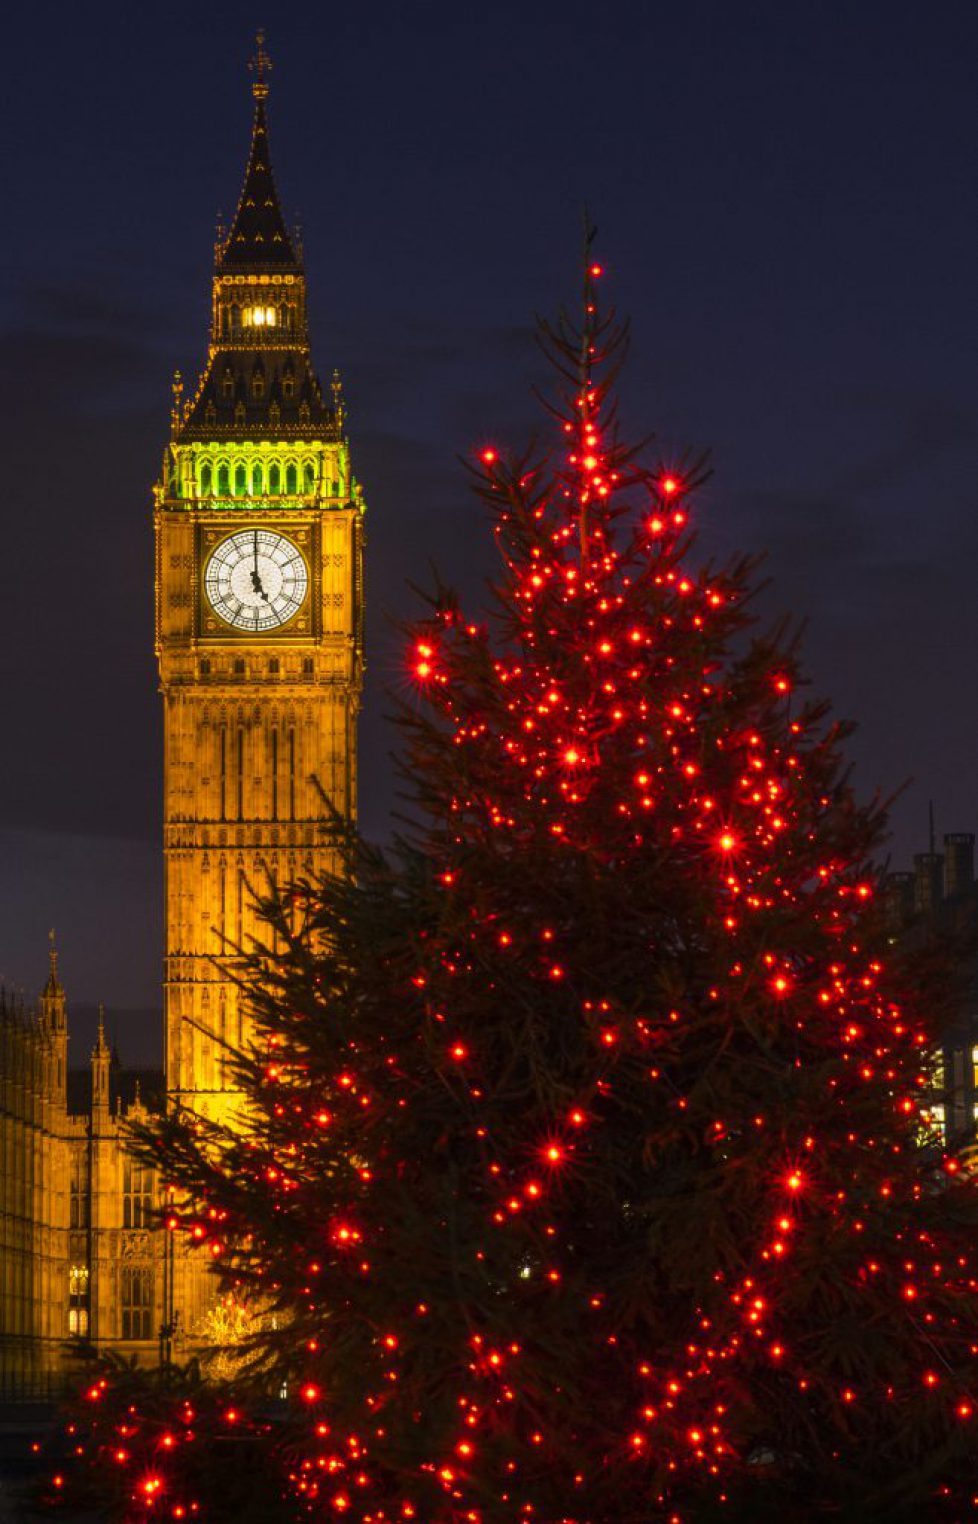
0;0;978;1062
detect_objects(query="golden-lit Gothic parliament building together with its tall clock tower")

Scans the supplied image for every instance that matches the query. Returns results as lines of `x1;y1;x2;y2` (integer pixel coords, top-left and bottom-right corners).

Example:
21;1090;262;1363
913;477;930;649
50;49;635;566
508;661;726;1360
0;37;364;1399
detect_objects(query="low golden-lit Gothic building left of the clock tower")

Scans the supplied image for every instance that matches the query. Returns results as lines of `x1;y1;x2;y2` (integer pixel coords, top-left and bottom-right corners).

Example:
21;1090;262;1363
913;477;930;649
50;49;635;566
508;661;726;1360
0;936;163;1398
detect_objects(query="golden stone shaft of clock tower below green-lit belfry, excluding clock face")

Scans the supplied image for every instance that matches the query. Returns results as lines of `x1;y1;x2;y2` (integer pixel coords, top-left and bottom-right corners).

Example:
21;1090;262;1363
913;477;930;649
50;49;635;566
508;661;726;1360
157;472;363;1116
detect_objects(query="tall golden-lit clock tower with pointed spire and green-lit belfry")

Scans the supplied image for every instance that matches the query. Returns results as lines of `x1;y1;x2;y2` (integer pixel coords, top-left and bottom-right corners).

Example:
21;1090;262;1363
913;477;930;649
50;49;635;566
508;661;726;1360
155;37;364;1117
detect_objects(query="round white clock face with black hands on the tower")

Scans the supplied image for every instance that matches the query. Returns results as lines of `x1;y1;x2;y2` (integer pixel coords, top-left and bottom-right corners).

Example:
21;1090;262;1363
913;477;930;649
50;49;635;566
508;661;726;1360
204;529;309;631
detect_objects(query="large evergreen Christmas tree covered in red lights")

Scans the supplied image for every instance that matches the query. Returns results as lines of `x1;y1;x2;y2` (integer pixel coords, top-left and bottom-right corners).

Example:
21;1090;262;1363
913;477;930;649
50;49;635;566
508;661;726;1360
51;252;978;1524
